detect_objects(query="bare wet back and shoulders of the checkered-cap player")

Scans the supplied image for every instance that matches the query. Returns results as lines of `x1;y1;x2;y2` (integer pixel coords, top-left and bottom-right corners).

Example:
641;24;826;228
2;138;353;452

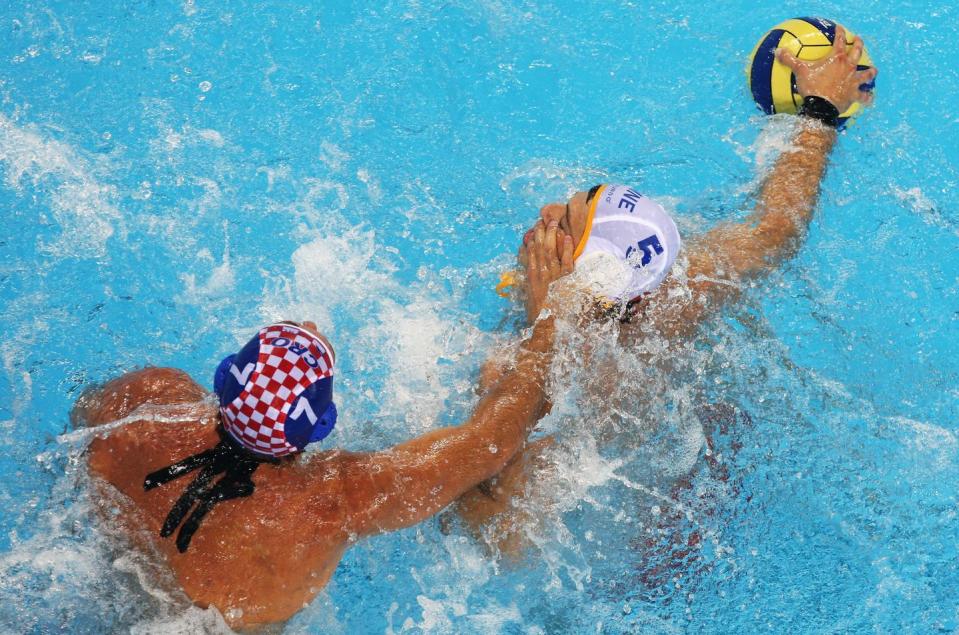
83;368;360;626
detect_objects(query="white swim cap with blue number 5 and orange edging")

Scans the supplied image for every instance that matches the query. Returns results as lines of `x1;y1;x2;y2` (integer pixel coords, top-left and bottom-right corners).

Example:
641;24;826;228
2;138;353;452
573;185;682;302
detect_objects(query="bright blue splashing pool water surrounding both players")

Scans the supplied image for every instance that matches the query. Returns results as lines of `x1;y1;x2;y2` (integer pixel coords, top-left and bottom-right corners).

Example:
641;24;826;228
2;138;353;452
0;0;959;633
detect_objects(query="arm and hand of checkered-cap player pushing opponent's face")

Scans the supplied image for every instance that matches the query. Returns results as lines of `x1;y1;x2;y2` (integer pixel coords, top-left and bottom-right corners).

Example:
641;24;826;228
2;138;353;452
348;222;573;535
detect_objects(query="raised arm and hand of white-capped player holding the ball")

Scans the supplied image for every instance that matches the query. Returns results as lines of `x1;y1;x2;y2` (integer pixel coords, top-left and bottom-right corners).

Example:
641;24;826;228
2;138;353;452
663;27;876;332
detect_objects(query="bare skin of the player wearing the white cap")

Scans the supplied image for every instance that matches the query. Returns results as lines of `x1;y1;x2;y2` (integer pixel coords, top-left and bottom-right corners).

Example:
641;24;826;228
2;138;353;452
457;26;877;556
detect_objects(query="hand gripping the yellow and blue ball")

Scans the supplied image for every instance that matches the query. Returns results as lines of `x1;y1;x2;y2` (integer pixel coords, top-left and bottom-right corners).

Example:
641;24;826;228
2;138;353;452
776;25;878;113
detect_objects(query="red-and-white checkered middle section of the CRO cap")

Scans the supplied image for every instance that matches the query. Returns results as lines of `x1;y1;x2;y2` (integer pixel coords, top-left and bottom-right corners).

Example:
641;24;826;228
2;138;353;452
220;324;333;457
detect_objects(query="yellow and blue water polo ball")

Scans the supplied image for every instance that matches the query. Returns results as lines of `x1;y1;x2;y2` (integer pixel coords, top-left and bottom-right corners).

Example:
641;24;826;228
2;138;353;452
746;18;875;126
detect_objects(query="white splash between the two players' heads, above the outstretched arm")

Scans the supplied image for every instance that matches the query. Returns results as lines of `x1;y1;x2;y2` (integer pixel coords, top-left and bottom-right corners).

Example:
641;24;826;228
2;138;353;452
260;221;482;442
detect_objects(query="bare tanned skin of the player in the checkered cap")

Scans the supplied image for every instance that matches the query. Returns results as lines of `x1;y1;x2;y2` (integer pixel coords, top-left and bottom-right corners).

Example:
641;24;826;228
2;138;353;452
79;222;573;628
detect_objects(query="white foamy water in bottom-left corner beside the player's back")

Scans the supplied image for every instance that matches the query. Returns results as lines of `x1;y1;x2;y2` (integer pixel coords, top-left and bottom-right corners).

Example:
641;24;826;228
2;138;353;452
0;432;232;635
